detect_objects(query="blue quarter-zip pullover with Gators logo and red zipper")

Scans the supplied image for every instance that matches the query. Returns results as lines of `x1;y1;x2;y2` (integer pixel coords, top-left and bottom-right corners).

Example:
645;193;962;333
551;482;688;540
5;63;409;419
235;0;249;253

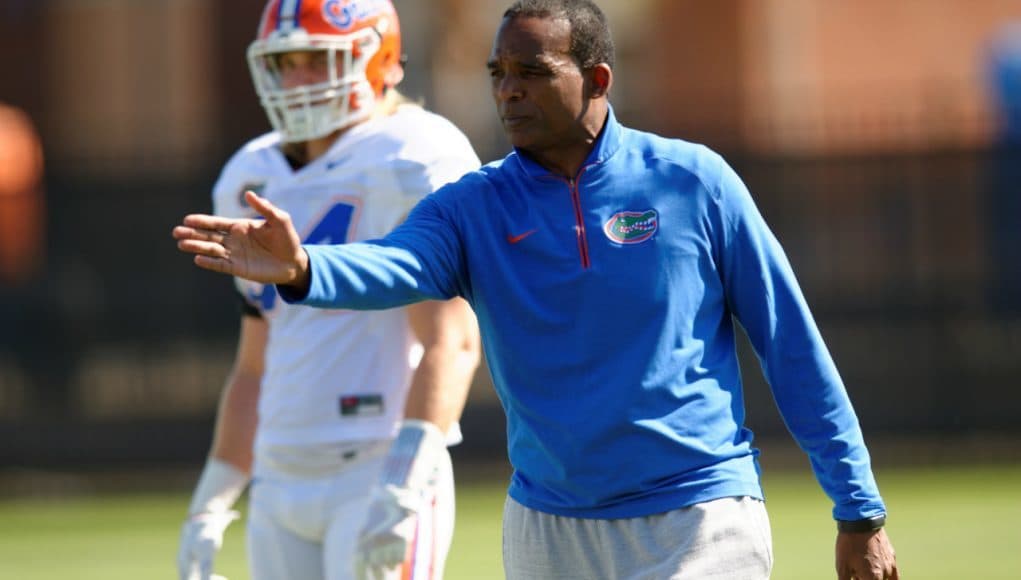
282;110;885;520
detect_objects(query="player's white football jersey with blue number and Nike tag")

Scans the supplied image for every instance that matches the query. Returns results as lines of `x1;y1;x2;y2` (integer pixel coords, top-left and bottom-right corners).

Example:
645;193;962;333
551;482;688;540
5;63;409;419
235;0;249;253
213;105;480;448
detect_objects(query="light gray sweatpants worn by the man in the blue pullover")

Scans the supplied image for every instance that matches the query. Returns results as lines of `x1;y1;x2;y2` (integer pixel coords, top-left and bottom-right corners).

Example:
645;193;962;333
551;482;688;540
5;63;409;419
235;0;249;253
503;497;773;580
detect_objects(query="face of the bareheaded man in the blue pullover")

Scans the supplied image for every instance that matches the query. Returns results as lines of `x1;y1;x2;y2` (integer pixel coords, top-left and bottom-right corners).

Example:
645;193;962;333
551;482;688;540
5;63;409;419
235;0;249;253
487;16;601;161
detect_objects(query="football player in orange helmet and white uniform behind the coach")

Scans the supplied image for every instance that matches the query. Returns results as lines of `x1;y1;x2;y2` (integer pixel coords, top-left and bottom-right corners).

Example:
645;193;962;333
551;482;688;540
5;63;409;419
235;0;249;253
178;0;480;580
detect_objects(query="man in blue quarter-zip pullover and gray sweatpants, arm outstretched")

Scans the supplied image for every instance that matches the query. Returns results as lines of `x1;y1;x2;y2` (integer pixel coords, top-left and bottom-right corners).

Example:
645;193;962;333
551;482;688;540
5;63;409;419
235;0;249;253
174;0;898;580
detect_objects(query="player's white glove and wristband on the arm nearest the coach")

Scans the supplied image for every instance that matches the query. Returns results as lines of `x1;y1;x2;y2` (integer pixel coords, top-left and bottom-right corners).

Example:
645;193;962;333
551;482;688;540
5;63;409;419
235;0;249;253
355;420;446;579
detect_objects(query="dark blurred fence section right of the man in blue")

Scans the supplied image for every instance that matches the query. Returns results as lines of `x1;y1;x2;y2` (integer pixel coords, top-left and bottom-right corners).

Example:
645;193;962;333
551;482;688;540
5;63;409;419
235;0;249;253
738;149;1021;435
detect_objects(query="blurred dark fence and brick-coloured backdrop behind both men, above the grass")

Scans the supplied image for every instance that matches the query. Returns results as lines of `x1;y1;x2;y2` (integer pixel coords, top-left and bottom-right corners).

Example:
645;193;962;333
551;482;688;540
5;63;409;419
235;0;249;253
0;0;1021;575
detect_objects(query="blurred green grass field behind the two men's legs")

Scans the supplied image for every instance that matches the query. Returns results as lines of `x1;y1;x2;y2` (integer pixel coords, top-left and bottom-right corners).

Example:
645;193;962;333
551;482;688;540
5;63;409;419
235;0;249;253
0;466;1021;580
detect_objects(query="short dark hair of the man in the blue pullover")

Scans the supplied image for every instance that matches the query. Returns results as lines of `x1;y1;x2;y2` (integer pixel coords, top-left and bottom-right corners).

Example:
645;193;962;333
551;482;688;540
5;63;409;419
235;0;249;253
503;0;614;69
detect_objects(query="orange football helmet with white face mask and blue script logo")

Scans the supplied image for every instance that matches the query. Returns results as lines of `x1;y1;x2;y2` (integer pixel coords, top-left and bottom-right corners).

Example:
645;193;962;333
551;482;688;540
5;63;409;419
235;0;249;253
248;0;404;142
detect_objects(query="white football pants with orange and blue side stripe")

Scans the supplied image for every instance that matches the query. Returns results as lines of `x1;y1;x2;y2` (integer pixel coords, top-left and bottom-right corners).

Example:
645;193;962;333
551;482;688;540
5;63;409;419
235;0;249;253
247;441;454;580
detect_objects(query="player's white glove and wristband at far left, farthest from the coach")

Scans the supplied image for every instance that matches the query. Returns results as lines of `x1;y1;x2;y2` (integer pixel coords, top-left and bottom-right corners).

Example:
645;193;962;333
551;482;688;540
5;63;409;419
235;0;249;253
178;457;248;580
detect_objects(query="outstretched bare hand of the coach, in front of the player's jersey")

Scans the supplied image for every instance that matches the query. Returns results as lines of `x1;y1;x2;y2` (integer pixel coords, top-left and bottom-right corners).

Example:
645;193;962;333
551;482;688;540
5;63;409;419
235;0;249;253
174;191;308;287
